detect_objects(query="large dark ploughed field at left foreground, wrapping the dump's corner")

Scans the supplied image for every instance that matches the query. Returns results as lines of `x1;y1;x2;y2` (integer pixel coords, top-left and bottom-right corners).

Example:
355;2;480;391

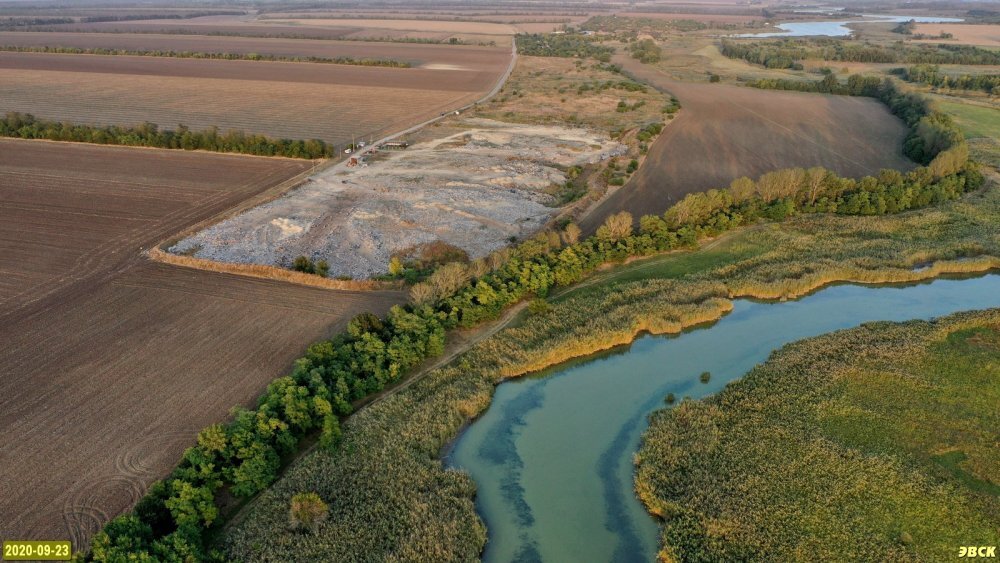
0;140;402;548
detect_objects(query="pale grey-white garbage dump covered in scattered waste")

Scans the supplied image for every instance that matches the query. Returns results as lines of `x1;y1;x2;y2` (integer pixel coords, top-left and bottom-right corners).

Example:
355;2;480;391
171;119;626;278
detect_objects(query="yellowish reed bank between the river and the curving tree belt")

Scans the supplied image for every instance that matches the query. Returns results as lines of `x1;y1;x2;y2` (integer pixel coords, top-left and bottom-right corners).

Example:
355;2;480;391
220;180;1000;561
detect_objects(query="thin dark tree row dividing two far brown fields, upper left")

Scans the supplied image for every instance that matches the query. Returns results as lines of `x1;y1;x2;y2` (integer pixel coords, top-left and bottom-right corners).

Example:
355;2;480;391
0;45;412;68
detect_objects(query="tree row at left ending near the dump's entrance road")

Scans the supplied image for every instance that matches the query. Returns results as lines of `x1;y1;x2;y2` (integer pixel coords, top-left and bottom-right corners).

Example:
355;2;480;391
0;112;334;159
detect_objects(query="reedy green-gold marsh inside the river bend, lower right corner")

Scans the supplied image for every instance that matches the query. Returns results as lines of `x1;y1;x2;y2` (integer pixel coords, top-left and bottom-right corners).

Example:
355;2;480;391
636;309;1000;561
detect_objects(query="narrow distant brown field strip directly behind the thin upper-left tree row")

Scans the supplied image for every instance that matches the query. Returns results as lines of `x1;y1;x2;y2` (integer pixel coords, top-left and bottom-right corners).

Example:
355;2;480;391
0;31;509;69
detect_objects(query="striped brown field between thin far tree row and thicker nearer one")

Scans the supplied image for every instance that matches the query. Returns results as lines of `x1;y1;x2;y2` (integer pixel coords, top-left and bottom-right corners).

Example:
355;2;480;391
0;49;510;144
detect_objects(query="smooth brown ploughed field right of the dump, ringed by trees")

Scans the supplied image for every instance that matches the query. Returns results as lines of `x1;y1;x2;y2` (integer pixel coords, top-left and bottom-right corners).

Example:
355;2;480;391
581;57;915;232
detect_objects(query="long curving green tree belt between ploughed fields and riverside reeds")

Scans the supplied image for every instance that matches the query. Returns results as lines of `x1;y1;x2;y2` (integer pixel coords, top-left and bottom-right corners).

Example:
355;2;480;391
87;77;983;561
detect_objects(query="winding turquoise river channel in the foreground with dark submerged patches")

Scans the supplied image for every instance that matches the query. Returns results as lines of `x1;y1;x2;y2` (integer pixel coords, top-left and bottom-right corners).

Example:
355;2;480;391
448;275;1000;562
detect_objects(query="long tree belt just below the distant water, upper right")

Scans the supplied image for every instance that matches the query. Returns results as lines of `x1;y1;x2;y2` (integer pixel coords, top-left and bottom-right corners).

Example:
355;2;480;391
720;39;1000;70
